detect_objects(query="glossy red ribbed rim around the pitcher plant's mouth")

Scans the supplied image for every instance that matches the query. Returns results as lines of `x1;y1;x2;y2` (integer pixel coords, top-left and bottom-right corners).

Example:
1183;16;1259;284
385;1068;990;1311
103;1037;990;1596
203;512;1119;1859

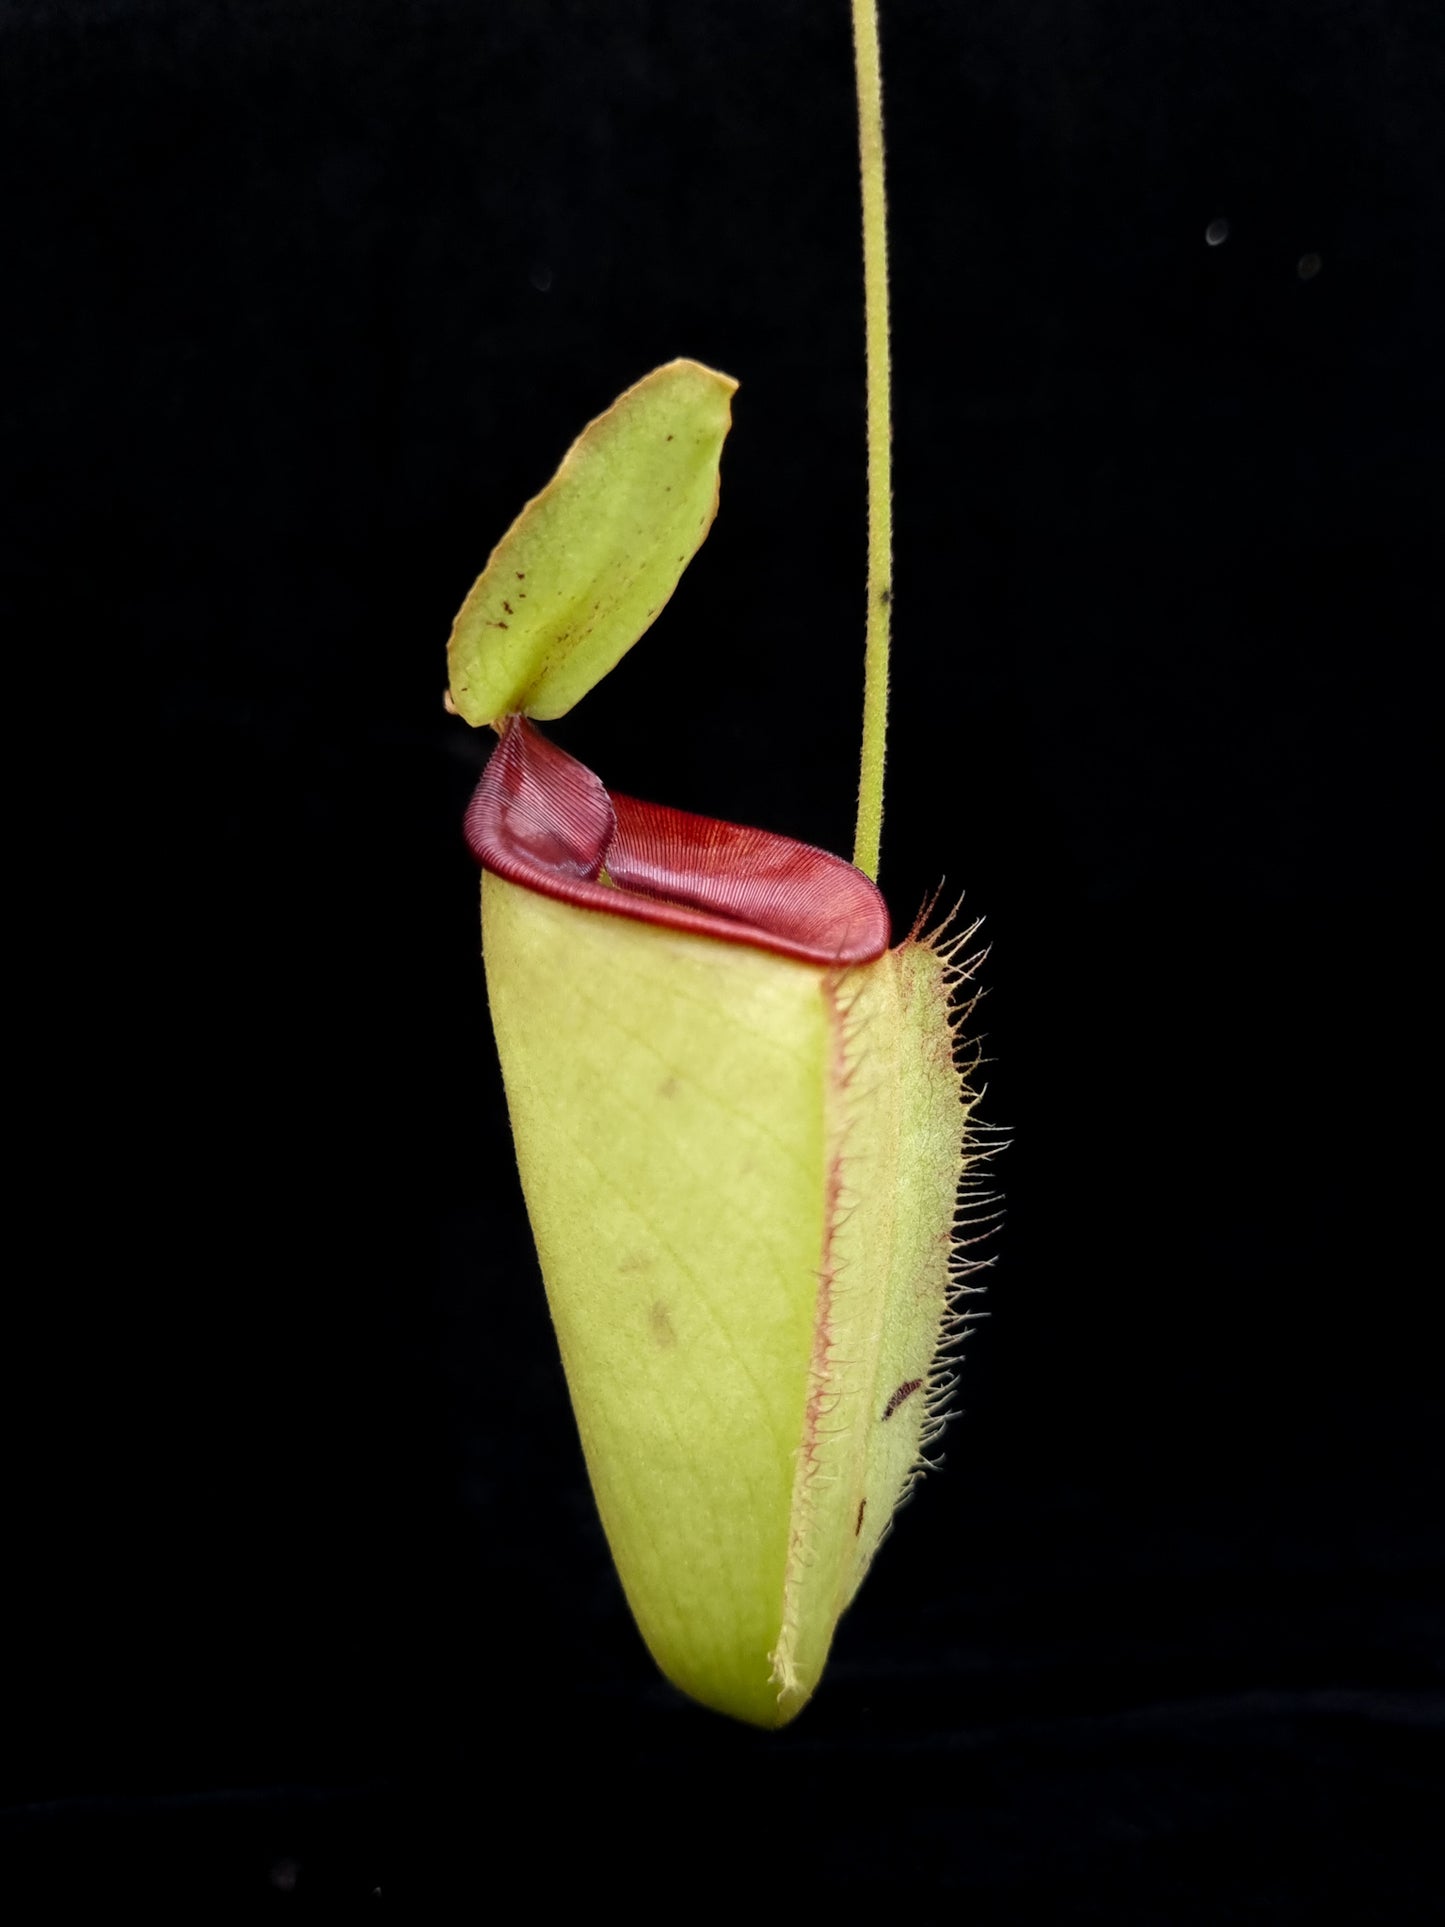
466;717;888;965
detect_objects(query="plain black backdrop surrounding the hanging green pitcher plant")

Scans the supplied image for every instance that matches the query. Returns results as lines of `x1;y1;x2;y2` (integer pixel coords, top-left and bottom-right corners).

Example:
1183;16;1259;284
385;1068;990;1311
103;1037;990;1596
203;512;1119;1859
0;0;1445;1923
